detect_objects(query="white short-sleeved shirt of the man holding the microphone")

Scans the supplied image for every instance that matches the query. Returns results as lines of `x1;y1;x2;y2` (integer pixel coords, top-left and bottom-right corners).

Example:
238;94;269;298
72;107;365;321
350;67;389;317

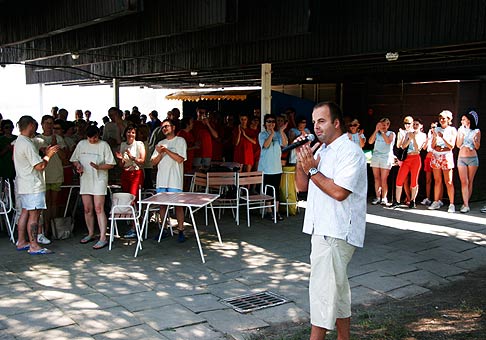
303;134;368;247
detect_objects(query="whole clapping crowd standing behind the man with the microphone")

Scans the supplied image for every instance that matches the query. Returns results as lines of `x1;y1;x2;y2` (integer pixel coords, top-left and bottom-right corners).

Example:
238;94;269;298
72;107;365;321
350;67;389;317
0;107;486;252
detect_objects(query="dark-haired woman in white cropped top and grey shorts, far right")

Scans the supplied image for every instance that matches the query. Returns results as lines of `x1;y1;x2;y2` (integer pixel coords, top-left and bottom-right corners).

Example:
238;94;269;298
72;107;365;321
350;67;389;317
456;111;481;213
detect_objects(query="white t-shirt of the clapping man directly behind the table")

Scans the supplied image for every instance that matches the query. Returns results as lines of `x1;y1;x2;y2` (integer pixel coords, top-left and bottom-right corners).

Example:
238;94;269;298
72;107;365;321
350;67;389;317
151;136;187;190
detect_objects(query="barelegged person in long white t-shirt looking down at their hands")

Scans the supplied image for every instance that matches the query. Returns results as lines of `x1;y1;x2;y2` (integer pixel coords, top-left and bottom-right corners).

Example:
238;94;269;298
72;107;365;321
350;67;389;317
70;125;116;249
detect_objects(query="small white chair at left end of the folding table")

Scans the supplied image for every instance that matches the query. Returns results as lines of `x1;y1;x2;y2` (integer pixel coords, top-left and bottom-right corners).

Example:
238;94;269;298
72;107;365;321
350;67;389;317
108;189;142;251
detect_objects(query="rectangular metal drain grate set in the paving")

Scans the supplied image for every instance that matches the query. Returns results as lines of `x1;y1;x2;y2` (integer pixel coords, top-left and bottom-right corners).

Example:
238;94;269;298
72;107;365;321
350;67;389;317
222;291;290;313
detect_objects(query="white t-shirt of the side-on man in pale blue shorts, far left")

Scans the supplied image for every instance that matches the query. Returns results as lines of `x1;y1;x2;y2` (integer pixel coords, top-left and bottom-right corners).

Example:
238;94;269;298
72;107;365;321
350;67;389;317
13;135;46;194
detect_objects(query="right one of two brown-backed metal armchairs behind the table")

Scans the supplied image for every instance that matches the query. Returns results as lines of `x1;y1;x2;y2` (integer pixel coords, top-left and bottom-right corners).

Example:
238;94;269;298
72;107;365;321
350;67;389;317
238;171;277;227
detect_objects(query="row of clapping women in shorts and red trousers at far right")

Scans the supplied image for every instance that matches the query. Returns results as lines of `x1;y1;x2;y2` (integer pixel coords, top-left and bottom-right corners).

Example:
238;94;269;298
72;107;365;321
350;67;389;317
368;110;486;213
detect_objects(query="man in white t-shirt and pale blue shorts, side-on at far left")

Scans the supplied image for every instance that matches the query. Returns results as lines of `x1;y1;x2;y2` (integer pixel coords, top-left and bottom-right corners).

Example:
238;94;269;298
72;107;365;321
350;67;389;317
13;116;59;255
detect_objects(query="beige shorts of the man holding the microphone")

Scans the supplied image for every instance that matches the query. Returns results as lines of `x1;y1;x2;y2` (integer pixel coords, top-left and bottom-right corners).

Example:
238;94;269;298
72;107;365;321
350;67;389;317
309;235;355;330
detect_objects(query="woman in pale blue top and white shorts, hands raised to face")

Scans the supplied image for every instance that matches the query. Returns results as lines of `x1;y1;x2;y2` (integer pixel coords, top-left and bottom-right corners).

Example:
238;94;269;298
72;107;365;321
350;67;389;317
368;118;396;205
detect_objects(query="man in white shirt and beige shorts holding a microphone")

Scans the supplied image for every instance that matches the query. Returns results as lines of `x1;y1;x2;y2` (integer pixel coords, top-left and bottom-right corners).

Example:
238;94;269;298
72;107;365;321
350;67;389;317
296;102;367;340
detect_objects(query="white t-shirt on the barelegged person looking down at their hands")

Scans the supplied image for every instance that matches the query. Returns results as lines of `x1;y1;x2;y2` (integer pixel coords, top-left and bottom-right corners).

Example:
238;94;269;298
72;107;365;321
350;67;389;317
69;139;116;195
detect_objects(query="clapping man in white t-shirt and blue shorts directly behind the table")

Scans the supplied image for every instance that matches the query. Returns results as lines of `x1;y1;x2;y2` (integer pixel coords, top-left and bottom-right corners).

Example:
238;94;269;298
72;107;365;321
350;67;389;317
151;119;187;242
